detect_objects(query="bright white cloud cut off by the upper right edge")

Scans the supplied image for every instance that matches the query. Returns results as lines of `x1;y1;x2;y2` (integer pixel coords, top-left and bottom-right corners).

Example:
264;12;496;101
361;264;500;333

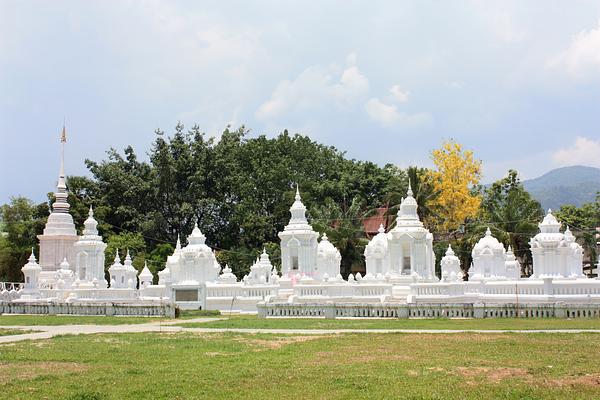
548;21;600;78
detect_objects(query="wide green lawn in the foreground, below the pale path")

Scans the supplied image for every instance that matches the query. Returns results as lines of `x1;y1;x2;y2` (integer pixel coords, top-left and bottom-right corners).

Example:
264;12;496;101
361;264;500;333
0;333;600;400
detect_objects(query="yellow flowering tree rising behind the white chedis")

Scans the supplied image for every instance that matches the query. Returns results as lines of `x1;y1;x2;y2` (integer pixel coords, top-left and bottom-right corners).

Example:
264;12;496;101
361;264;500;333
429;140;481;232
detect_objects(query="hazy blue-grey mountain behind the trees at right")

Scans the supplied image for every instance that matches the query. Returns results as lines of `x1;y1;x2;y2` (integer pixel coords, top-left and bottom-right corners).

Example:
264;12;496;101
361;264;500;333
523;166;600;210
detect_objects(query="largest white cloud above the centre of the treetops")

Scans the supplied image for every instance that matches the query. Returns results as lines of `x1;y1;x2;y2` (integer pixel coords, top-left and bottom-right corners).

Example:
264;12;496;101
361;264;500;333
256;54;369;120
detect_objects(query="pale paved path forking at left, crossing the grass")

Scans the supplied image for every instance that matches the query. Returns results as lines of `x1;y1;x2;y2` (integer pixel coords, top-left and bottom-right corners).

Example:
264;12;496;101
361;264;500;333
0;318;600;344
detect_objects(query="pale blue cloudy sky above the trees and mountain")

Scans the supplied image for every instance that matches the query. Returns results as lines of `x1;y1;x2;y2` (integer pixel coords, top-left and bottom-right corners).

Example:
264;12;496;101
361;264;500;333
0;0;600;203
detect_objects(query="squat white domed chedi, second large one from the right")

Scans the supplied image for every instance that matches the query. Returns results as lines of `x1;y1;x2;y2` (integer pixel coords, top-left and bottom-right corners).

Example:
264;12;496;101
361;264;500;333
469;228;506;281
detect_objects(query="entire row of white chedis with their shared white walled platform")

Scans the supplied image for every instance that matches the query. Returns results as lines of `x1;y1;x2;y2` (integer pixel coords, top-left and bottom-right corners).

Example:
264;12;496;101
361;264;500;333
7;130;600;316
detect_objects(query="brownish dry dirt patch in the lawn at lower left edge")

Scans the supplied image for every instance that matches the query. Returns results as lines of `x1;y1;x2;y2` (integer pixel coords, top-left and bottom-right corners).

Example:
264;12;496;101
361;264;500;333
0;361;88;384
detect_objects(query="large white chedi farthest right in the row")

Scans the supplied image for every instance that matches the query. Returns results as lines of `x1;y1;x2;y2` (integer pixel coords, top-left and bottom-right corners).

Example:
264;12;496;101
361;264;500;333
529;210;584;278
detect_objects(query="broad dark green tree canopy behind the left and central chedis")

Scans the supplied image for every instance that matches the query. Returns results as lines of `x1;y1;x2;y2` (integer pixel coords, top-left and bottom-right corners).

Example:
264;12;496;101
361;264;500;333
74;124;398;276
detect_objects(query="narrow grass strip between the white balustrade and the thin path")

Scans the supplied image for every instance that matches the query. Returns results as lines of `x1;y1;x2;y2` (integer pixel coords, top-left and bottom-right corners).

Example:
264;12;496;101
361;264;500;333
178;315;600;329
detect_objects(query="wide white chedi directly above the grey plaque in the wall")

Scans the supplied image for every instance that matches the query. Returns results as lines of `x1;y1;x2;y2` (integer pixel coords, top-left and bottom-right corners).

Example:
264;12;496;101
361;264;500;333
164;223;221;285
